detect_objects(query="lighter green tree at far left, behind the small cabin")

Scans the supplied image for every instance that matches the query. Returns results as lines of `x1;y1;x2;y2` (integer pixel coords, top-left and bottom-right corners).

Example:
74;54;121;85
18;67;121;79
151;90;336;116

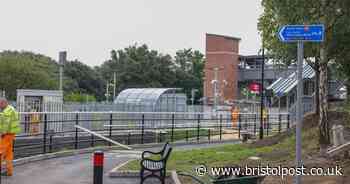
0;51;58;100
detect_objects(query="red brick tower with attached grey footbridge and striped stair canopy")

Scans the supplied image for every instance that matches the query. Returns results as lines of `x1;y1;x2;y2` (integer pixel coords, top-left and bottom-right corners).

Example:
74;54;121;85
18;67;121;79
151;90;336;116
203;34;344;118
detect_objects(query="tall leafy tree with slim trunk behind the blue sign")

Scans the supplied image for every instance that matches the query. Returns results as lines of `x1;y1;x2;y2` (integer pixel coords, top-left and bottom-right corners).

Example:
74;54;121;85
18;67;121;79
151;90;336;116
258;0;350;151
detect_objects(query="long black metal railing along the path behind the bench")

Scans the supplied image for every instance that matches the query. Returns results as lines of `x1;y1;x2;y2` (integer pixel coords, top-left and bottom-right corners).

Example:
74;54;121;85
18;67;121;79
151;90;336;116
14;111;292;158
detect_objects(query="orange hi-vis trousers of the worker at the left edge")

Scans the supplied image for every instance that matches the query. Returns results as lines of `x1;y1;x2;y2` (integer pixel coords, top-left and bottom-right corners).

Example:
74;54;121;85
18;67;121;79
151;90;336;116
0;134;15;176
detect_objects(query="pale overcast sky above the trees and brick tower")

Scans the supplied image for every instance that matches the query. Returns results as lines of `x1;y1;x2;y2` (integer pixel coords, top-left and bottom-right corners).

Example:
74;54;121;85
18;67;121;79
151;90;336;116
0;0;262;66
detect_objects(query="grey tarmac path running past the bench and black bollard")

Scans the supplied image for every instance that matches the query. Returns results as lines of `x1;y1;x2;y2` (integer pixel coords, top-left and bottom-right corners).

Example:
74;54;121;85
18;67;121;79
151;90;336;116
1;143;238;184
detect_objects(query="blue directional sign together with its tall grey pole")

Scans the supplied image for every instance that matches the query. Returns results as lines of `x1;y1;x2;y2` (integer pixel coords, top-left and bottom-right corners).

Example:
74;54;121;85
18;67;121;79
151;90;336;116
278;24;324;184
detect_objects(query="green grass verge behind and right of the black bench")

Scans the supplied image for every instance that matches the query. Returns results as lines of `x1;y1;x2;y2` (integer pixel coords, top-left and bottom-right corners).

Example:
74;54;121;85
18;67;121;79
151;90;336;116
121;122;318;181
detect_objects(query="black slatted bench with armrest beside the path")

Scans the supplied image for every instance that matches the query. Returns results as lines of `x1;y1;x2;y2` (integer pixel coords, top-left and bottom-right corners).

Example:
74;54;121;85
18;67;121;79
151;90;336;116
140;142;172;184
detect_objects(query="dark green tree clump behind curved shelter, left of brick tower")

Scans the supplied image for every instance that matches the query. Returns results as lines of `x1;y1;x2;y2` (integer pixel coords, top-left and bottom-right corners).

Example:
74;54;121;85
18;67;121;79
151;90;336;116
98;44;204;103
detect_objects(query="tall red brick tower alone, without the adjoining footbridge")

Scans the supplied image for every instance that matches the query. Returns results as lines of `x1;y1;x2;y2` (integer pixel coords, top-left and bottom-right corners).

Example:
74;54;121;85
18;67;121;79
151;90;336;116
203;34;241;104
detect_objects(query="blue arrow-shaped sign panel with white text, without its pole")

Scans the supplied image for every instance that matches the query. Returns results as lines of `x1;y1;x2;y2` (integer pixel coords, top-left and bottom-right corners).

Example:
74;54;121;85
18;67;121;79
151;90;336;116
278;24;324;42
